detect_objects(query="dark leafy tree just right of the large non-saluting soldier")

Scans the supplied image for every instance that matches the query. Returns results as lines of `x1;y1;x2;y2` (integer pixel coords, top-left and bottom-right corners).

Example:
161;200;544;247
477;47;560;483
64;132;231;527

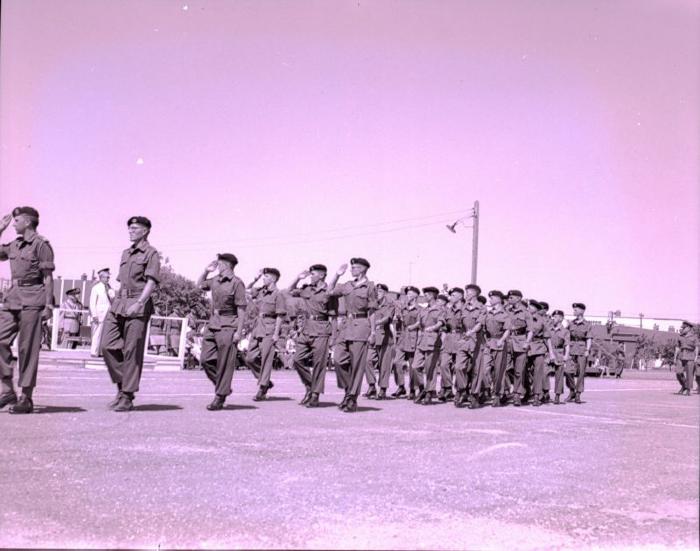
153;255;209;319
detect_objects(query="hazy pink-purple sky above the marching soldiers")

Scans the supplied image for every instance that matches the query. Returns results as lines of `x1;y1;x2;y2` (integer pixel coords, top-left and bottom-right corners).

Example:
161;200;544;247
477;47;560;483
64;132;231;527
0;0;700;320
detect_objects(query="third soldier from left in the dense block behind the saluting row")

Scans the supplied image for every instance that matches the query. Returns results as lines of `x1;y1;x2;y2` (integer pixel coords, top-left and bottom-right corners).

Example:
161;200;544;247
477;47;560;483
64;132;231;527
409;287;447;405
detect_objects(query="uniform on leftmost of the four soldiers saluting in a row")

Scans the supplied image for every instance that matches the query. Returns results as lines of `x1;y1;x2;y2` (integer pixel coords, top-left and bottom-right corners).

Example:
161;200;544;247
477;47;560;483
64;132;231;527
200;273;248;403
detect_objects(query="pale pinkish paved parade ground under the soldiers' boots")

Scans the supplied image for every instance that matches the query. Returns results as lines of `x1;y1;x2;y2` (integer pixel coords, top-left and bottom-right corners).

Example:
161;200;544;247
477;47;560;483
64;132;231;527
0;368;700;549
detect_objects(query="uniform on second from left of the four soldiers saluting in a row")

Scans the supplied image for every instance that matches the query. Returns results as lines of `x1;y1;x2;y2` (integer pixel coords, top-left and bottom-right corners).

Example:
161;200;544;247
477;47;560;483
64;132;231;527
245;286;287;393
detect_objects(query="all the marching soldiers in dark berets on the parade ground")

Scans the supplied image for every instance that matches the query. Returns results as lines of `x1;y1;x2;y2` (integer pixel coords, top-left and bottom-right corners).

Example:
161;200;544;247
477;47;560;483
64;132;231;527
0;207;698;413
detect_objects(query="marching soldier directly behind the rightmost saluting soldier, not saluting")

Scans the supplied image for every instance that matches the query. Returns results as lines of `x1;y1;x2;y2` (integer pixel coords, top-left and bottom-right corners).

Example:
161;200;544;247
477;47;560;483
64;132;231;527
367;283;396;400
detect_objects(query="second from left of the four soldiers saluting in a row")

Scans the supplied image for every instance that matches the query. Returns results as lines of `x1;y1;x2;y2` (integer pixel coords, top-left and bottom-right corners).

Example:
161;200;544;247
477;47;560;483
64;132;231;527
245;268;287;402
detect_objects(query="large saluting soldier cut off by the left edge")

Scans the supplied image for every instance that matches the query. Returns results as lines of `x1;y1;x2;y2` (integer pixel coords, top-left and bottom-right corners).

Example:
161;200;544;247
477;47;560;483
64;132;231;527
0;207;55;414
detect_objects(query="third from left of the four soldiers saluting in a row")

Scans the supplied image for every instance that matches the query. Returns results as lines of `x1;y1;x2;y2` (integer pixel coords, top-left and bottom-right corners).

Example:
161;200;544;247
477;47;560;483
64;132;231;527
289;264;333;408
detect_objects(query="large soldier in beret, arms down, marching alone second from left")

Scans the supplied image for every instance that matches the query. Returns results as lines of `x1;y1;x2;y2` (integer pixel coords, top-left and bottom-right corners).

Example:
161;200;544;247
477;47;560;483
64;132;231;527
100;216;160;411
